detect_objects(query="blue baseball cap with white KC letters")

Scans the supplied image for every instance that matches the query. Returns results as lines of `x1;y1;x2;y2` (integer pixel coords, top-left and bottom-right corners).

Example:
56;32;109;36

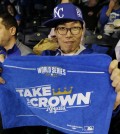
43;3;83;27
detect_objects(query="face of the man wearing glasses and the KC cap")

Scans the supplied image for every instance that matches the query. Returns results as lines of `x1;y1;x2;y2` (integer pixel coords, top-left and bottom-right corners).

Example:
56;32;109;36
55;21;82;54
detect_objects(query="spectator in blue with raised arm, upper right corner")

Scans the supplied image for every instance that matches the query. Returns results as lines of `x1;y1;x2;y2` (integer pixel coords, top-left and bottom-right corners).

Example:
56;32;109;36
99;0;120;35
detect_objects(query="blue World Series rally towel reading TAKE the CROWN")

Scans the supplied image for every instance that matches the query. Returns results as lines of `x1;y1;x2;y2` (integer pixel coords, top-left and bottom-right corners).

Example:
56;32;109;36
0;54;116;134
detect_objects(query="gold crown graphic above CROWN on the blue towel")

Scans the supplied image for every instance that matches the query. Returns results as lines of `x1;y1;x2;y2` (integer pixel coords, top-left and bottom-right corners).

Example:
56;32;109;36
52;86;73;95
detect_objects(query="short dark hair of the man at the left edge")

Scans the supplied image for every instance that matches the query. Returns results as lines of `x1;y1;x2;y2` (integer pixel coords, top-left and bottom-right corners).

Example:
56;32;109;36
0;12;18;36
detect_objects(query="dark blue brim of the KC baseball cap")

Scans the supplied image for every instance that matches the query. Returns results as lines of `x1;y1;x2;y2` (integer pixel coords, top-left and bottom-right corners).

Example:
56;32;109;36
43;18;83;28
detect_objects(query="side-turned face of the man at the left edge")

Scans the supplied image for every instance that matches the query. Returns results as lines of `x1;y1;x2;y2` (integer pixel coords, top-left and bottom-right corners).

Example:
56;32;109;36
0;18;11;47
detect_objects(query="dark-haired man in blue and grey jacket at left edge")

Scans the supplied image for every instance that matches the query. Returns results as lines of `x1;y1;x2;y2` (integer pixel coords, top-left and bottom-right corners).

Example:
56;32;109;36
0;13;32;62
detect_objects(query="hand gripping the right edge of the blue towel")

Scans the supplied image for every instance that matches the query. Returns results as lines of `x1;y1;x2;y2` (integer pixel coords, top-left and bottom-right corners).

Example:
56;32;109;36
109;60;120;109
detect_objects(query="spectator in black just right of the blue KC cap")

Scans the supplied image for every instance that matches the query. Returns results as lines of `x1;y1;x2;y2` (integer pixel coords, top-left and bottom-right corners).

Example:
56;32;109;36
79;0;101;35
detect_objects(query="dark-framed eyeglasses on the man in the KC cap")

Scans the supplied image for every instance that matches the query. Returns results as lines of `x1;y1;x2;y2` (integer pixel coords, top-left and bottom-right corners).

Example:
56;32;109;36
56;27;82;35
